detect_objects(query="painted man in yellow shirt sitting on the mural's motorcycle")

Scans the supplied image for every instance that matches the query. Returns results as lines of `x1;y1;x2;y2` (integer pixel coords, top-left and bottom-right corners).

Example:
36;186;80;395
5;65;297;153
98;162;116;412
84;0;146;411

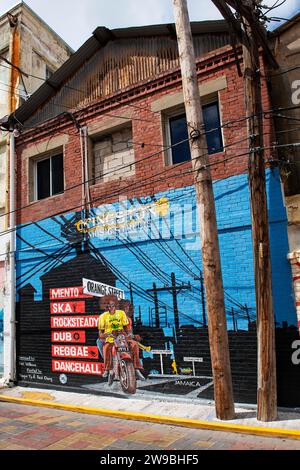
98;300;144;380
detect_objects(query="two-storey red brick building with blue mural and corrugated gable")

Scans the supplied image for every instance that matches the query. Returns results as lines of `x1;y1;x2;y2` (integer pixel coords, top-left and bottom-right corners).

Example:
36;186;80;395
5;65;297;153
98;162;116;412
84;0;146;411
4;21;298;405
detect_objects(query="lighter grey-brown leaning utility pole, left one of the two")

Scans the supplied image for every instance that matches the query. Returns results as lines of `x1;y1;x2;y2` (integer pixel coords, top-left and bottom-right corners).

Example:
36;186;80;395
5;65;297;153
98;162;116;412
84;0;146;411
173;0;234;420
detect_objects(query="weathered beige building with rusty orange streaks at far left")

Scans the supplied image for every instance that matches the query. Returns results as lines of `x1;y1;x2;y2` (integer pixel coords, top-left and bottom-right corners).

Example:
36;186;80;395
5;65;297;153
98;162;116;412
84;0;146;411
0;2;73;382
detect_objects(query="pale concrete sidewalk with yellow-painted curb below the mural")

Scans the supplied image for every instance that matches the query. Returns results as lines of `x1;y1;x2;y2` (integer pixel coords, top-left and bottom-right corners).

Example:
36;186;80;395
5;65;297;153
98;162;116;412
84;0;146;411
0;387;300;439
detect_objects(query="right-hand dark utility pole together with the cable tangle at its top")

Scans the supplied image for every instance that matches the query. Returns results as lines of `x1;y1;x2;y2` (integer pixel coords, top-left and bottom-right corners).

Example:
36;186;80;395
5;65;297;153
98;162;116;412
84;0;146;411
212;0;278;421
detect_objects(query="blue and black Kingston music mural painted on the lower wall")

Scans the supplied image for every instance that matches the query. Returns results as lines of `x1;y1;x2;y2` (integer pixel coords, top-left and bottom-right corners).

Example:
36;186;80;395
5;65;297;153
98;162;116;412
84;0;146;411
17;173;294;403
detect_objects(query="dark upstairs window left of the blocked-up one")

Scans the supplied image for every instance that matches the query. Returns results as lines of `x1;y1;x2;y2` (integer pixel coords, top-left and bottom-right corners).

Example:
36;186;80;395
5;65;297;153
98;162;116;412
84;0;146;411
35;154;64;200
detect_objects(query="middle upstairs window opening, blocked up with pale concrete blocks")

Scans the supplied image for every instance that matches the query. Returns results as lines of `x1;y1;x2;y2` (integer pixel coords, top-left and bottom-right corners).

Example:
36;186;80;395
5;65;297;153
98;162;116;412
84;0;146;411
92;127;135;183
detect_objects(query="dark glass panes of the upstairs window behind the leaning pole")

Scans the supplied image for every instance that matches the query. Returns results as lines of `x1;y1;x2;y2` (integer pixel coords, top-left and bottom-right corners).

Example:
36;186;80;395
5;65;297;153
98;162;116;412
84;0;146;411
169;102;223;165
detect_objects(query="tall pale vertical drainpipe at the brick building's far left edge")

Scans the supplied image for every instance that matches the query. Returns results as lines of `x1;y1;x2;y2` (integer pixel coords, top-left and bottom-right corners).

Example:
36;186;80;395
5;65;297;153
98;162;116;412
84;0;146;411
9;129;16;385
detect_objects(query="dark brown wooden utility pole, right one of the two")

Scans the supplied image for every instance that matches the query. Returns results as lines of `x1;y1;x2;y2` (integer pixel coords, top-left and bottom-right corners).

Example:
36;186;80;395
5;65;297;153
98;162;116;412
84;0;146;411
242;11;277;421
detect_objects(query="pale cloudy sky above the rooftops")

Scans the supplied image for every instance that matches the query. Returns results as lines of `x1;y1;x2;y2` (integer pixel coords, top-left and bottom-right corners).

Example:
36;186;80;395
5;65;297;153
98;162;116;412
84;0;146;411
0;0;300;50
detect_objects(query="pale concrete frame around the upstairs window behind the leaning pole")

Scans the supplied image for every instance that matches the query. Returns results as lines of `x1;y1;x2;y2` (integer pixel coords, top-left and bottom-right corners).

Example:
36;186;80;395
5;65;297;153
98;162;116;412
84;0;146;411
162;93;225;166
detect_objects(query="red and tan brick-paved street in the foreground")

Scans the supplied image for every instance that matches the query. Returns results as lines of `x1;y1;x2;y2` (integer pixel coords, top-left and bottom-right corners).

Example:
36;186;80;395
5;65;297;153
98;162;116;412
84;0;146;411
0;403;300;450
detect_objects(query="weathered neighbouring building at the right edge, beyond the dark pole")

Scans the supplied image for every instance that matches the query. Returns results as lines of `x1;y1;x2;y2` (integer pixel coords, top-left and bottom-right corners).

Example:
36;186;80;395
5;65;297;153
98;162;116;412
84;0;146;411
271;13;300;330
